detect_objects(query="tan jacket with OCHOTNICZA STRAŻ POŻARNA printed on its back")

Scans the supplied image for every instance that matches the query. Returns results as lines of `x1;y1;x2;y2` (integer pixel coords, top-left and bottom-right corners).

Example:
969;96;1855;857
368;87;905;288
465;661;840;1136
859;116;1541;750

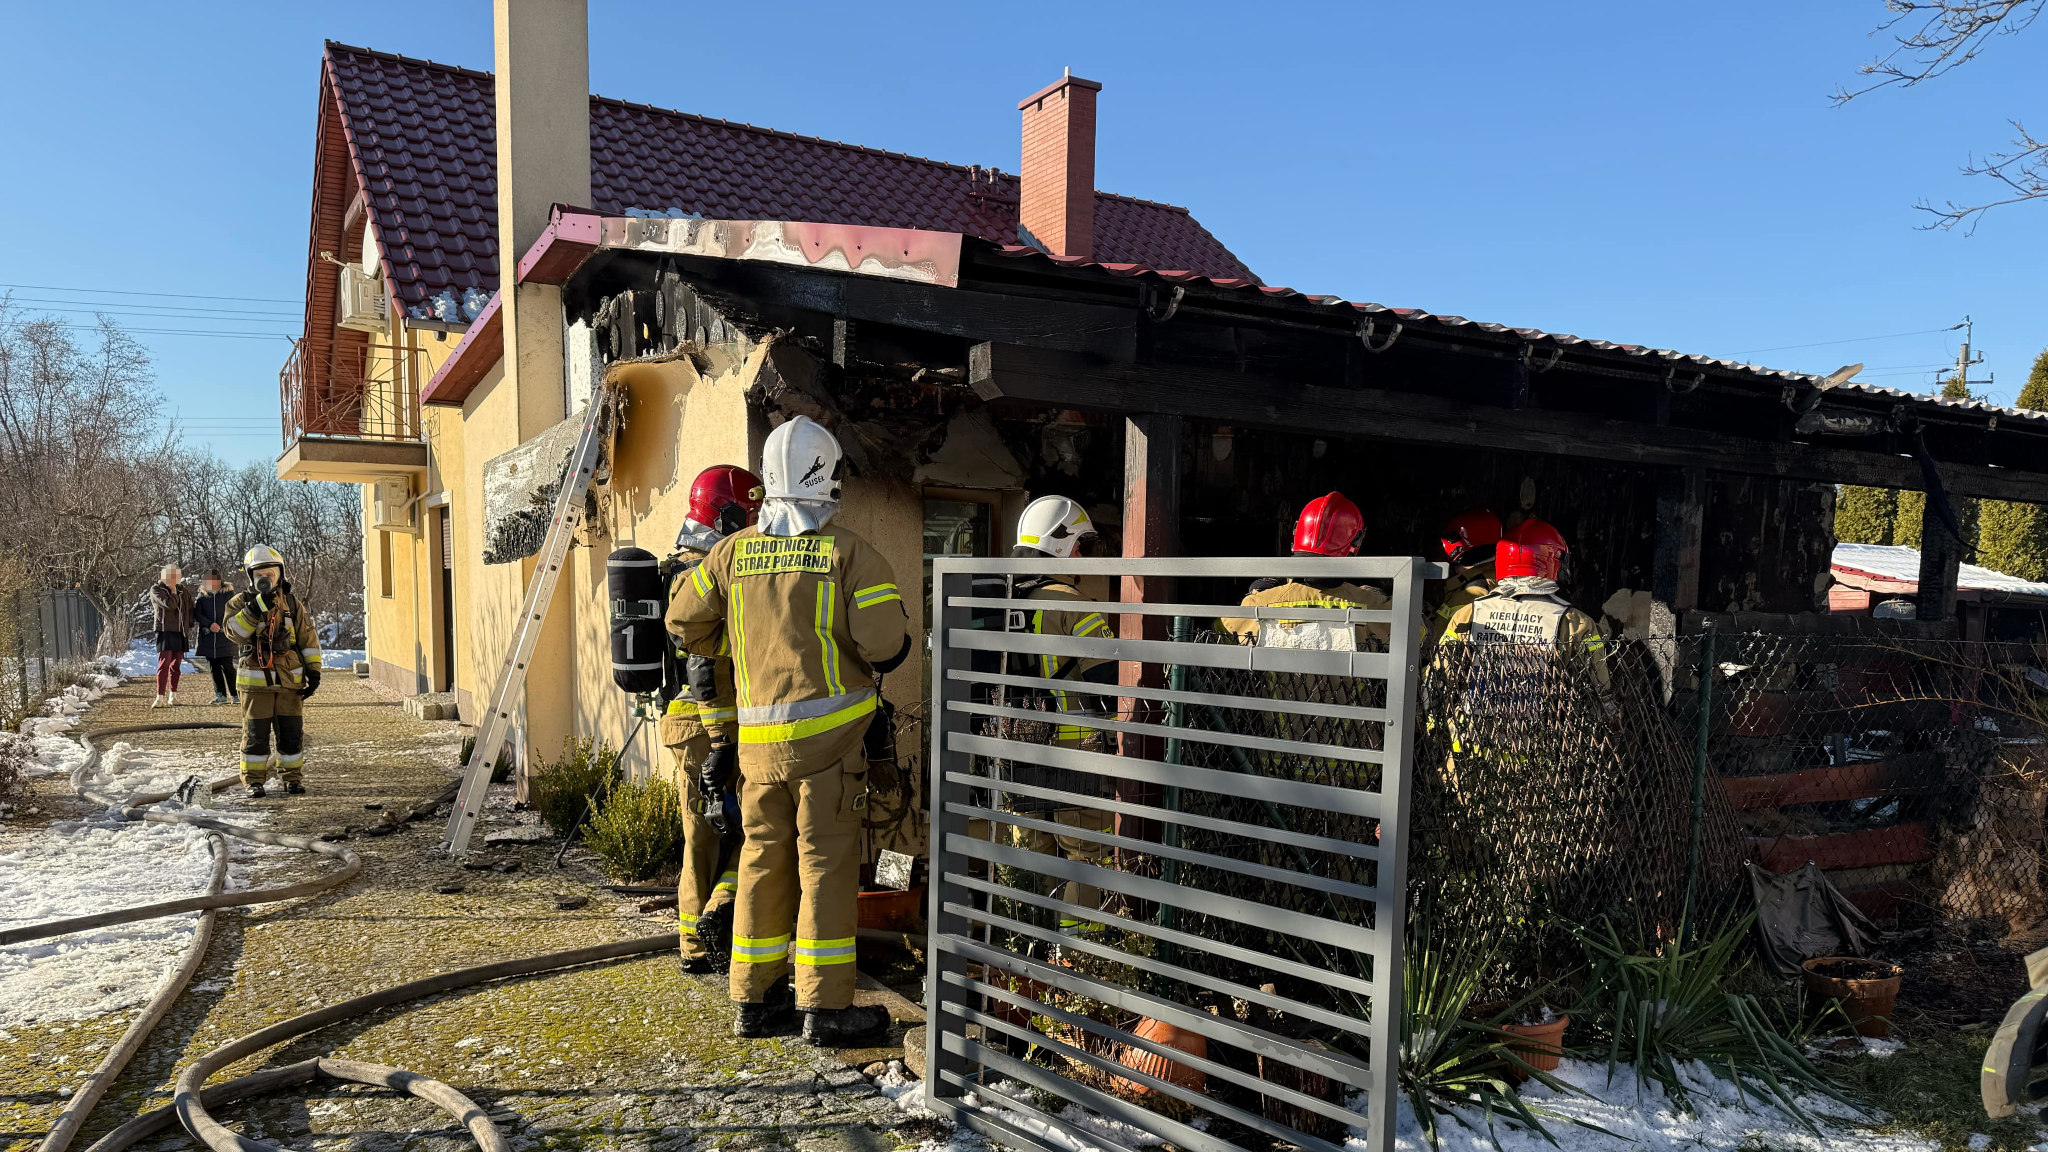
668;525;909;783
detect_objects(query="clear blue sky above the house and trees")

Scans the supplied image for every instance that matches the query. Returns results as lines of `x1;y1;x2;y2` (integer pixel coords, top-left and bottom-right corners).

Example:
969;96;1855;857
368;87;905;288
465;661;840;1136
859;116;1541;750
0;0;2048;461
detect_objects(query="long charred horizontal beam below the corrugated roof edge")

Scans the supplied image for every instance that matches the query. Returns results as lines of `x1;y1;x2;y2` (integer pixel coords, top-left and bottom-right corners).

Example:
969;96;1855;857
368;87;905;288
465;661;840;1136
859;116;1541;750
969;342;2048;504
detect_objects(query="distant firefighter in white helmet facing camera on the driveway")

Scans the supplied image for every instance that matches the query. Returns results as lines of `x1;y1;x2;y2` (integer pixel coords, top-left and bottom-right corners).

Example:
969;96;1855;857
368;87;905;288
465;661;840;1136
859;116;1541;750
221;543;319;797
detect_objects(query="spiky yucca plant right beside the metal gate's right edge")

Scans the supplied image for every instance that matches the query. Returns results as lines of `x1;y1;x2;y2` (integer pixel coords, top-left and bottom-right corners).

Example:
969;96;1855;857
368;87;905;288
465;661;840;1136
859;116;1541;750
1401;910;1606;1148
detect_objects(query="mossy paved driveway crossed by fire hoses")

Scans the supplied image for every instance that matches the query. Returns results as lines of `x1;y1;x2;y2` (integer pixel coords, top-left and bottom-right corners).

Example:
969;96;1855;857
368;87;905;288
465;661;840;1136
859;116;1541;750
0;674;915;1152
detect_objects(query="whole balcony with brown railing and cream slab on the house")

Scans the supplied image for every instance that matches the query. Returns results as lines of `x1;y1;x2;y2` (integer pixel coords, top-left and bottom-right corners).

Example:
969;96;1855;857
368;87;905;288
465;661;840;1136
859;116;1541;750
276;332;426;484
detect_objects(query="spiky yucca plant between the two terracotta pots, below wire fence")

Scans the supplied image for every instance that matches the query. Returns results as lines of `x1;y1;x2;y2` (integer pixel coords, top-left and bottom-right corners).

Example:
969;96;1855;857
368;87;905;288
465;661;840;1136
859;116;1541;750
1571;914;1843;1132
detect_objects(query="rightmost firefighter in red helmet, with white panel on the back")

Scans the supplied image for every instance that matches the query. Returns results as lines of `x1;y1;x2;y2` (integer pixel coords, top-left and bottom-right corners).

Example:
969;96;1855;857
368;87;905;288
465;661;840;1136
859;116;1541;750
1444;521;1614;696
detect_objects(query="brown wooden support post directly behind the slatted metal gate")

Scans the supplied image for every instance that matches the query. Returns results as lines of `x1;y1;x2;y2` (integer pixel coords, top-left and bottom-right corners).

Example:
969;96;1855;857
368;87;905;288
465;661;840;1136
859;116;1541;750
1116;412;1182;840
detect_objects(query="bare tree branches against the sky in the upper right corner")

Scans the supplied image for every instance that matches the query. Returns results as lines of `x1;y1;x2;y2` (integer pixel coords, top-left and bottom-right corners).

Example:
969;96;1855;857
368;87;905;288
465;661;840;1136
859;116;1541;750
1835;0;2048;234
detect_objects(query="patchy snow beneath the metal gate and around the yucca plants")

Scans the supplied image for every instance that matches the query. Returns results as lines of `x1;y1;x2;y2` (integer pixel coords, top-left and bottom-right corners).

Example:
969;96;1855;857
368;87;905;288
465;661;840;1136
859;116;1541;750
874;1054;1939;1152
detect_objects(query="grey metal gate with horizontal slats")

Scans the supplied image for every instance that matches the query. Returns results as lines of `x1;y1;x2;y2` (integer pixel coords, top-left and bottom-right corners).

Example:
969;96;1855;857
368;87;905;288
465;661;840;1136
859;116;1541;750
926;558;1444;1152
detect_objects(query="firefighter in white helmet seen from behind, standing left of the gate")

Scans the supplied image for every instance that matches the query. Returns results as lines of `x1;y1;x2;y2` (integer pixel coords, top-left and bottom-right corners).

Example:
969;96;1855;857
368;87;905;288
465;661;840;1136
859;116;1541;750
668;416;911;1045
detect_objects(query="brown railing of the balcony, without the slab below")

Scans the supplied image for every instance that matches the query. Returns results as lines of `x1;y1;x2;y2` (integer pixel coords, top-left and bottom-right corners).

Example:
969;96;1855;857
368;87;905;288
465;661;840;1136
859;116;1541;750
276;338;426;447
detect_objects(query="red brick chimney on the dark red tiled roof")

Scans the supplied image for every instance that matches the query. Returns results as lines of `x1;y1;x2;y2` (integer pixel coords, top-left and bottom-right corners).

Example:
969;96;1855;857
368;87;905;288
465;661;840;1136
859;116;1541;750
1018;72;1102;256
